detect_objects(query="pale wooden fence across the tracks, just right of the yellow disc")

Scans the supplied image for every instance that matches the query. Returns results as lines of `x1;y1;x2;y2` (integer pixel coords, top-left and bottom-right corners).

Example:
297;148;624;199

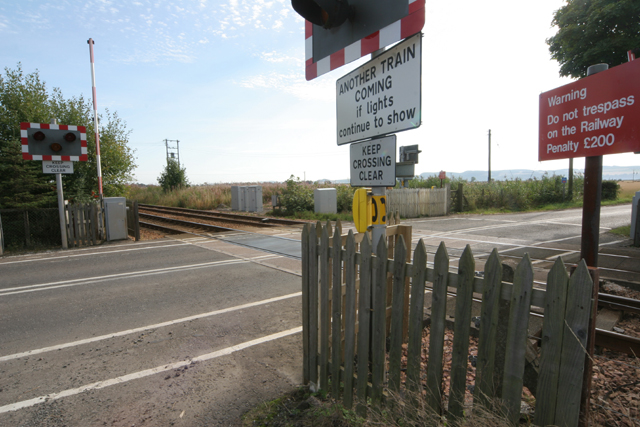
387;184;450;218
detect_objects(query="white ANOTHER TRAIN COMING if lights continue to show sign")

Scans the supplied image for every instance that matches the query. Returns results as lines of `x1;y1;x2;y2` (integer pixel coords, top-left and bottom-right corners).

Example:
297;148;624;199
336;33;422;145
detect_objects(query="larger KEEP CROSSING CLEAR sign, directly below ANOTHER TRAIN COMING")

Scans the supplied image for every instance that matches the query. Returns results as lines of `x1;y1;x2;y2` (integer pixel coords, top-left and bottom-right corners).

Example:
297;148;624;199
350;135;396;187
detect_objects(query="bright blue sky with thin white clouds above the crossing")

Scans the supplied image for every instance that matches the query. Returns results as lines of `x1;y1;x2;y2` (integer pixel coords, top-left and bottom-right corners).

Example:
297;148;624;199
0;0;640;184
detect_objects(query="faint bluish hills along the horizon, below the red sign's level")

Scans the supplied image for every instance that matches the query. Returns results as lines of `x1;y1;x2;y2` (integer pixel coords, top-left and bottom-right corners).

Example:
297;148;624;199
420;166;640;181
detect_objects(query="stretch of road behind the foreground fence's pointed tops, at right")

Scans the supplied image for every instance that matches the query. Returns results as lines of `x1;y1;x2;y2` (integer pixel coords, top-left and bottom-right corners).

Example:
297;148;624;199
403;205;640;282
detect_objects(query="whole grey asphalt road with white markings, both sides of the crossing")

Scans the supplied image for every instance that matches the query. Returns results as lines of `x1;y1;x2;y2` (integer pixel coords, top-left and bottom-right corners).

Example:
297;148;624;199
0;205;639;427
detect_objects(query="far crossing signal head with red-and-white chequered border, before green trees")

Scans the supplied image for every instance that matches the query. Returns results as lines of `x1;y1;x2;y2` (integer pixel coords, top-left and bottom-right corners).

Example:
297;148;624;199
20;123;87;161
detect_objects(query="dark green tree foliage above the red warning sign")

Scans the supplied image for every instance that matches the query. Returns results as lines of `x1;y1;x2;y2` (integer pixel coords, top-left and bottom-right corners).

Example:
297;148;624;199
547;0;640;78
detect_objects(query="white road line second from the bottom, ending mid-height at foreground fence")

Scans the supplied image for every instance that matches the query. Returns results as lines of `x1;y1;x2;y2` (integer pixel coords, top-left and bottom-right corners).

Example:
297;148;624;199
0;292;302;362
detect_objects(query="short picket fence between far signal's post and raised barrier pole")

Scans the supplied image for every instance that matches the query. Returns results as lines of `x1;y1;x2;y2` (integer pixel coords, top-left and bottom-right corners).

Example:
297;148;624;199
65;203;104;248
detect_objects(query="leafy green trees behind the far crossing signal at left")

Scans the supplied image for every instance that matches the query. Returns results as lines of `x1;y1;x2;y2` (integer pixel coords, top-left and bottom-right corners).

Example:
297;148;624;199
0;64;136;208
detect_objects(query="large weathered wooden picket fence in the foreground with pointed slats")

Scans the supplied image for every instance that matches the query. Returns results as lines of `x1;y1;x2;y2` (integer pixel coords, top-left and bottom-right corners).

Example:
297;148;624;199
302;223;593;426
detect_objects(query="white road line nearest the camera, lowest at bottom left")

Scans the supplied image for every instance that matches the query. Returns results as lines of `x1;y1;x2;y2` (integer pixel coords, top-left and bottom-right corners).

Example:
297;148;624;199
0;327;302;414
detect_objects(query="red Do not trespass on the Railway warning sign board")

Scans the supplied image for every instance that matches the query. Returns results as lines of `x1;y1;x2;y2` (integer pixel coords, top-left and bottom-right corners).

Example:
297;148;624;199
538;61;640;161
